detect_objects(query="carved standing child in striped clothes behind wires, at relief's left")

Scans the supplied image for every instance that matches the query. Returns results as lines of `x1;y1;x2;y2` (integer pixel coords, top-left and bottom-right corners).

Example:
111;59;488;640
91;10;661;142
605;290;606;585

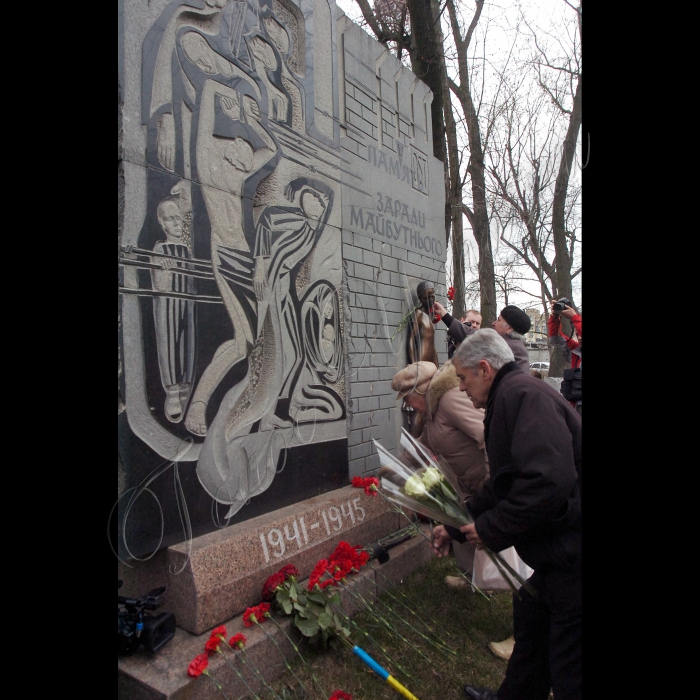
151;180;196;423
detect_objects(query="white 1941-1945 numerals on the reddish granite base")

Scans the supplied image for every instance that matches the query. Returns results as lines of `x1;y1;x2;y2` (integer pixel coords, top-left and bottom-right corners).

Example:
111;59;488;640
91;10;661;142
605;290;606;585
260;497;365;563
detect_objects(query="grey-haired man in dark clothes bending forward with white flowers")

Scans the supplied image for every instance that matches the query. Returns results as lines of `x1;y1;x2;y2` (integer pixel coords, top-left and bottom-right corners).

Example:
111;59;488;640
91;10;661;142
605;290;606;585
433;329;581;700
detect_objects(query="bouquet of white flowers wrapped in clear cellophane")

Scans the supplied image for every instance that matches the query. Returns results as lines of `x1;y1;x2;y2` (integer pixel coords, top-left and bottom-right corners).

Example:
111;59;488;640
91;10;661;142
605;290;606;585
373;430;536;595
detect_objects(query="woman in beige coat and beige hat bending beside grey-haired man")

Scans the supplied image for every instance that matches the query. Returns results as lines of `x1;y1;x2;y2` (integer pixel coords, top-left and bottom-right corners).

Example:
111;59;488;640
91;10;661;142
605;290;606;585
391;361;489;586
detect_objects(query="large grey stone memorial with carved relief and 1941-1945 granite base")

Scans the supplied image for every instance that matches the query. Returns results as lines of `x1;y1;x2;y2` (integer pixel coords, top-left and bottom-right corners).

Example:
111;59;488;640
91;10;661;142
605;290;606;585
117;0;446;692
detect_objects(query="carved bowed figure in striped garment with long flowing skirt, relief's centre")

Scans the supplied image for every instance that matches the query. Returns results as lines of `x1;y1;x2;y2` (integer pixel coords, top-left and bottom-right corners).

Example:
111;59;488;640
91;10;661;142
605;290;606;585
197;177;342;517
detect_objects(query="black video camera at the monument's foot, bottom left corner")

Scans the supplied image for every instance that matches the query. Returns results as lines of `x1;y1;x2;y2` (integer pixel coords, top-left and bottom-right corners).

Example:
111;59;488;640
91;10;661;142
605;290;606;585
117;580;175;656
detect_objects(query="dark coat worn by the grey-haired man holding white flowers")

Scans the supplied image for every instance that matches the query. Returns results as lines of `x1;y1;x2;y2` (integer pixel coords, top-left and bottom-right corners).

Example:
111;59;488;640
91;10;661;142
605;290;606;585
467;362;581;571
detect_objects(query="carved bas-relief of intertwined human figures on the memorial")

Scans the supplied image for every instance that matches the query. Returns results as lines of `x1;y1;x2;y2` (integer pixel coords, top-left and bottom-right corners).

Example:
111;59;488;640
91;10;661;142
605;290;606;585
120;0;345;532
